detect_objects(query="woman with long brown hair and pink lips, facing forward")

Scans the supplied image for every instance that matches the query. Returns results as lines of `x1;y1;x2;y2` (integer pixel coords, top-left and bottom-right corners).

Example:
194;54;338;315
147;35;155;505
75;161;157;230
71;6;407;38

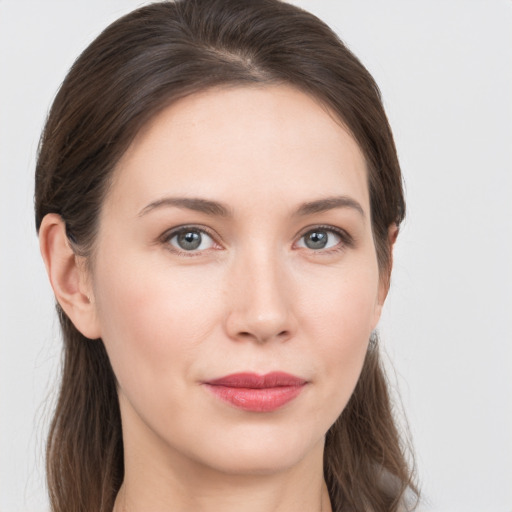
36;0;416;512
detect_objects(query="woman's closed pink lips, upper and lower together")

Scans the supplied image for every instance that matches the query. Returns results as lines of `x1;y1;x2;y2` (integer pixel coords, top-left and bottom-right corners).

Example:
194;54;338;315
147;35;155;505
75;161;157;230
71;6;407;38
203;372;307;412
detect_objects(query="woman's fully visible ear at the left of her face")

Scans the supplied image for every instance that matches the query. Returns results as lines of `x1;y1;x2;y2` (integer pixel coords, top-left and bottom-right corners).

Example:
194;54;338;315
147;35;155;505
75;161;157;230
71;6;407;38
39;213;101;339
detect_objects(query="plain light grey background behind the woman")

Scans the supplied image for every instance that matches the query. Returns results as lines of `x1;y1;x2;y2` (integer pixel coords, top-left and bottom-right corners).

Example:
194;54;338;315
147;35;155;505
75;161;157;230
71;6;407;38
0;0;512;512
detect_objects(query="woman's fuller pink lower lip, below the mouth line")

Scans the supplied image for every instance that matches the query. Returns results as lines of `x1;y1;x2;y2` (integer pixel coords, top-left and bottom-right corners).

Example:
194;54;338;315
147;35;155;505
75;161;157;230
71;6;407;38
205;384;304;412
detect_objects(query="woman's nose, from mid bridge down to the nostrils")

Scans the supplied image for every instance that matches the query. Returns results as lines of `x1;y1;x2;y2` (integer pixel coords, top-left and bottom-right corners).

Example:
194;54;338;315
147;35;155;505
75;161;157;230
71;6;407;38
226;247;297;343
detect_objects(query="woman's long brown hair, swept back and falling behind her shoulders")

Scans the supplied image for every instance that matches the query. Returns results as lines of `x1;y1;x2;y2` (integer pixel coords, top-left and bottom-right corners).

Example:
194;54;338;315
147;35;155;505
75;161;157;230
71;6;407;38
35;0;417;512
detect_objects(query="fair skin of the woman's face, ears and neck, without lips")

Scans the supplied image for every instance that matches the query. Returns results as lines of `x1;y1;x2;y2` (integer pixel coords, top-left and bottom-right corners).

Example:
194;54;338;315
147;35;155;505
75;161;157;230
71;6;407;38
40;86;394;512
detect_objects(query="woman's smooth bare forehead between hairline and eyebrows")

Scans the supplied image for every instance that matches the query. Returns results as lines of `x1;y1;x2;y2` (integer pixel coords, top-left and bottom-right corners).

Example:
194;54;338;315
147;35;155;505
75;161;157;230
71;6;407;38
105;85;368;216
